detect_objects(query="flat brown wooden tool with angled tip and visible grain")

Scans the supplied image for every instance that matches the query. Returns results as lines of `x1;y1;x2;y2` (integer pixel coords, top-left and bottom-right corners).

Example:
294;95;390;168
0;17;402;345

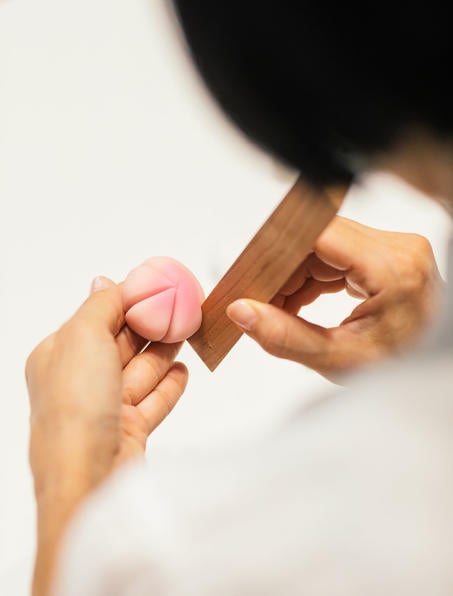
188;178;348;371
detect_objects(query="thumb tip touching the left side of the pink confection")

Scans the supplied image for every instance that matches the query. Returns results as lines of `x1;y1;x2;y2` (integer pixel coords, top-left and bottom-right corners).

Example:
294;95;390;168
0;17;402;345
73;277;124;336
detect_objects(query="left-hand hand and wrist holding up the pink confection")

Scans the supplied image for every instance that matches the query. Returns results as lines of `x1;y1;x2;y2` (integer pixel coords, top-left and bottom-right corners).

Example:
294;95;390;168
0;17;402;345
26;278;187;596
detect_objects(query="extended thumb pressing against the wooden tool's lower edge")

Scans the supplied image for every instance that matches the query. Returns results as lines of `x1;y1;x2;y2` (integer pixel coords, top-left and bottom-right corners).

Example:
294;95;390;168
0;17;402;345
226;299;335;374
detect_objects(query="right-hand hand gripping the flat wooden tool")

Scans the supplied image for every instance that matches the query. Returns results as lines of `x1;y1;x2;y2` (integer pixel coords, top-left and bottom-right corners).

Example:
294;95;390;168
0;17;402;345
227;217;442;380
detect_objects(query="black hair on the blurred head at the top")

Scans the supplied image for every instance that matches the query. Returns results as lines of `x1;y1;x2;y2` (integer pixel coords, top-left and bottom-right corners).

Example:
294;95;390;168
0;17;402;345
174;0;453;184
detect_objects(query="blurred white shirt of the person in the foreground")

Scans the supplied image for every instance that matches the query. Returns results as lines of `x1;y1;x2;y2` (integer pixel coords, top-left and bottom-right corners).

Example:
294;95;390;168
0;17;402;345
56;355;453;596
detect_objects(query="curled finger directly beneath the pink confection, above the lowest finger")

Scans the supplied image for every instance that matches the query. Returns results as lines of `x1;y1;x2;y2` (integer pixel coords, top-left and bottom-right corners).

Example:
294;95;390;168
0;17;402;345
123;343;182;406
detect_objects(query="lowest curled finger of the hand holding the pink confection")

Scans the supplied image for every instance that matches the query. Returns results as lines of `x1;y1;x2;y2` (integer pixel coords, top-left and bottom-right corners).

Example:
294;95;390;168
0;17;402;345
137;362;189;434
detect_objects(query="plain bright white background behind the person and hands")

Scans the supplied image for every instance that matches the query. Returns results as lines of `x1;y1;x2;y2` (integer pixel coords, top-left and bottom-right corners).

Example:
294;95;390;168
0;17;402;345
0;0;449;596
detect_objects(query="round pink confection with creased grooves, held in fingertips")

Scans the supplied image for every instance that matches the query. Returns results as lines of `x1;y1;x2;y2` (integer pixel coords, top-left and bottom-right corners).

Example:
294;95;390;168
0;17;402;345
123;257;203;343
